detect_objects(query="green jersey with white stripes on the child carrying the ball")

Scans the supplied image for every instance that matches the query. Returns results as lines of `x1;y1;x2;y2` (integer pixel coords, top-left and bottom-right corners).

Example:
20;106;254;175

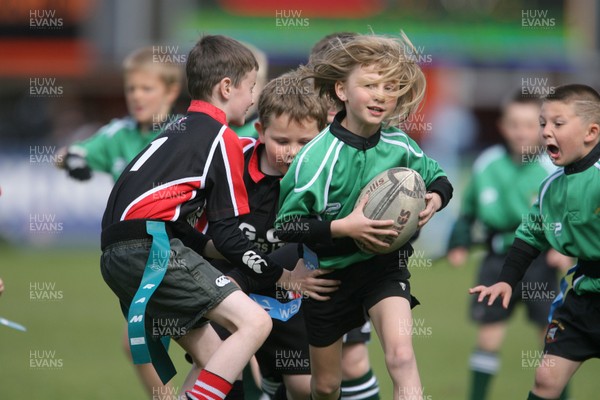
275;112;451;268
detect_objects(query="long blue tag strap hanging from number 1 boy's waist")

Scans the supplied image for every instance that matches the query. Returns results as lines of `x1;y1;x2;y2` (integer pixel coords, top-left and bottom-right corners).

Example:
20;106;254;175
127;221;177;384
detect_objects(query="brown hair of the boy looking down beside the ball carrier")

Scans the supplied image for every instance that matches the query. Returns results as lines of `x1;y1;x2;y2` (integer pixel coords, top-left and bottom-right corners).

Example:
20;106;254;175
258;70;328;130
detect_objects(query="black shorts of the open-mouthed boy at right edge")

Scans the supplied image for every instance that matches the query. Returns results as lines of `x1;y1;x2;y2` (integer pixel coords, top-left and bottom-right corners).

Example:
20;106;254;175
544;290;600;362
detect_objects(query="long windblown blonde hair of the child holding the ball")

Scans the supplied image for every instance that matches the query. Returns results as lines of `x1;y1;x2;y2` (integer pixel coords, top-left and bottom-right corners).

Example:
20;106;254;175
302;32;426;125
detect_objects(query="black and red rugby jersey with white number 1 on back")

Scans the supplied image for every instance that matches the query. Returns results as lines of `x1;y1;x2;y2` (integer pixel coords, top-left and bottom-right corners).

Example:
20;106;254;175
102;100;249;231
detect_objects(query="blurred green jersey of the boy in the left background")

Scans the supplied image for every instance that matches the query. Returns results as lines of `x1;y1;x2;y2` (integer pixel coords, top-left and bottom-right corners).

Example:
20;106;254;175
69;116;177;182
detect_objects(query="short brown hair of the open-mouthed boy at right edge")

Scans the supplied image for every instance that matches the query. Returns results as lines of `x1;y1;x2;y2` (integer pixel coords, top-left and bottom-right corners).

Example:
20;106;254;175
542;84;600;124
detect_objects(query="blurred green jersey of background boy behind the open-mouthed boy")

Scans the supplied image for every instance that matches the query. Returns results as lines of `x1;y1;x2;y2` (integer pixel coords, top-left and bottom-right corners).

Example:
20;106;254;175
448;145;556;254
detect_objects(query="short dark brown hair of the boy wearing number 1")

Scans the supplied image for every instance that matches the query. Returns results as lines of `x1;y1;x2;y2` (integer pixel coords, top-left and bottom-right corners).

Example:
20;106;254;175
186;35;258;100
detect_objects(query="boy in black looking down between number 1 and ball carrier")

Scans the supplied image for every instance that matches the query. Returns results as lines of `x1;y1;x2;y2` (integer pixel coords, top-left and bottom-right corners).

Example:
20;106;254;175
209;71;335;400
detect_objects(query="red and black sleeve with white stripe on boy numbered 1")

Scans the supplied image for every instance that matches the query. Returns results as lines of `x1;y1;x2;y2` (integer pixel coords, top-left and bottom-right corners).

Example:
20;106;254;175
206;128;250;222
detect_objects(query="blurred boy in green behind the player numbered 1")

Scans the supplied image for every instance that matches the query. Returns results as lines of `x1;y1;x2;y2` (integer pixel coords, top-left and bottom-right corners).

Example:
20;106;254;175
58;47;183;181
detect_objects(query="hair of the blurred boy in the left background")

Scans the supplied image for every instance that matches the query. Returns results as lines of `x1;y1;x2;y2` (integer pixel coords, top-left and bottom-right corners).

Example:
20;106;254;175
123;46;183;86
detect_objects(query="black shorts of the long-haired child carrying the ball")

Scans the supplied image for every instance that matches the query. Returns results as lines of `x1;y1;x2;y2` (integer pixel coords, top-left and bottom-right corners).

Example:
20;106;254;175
302;258;419;347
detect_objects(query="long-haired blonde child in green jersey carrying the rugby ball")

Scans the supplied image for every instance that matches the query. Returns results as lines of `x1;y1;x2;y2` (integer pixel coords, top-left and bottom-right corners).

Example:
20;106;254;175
277;35;452;400
